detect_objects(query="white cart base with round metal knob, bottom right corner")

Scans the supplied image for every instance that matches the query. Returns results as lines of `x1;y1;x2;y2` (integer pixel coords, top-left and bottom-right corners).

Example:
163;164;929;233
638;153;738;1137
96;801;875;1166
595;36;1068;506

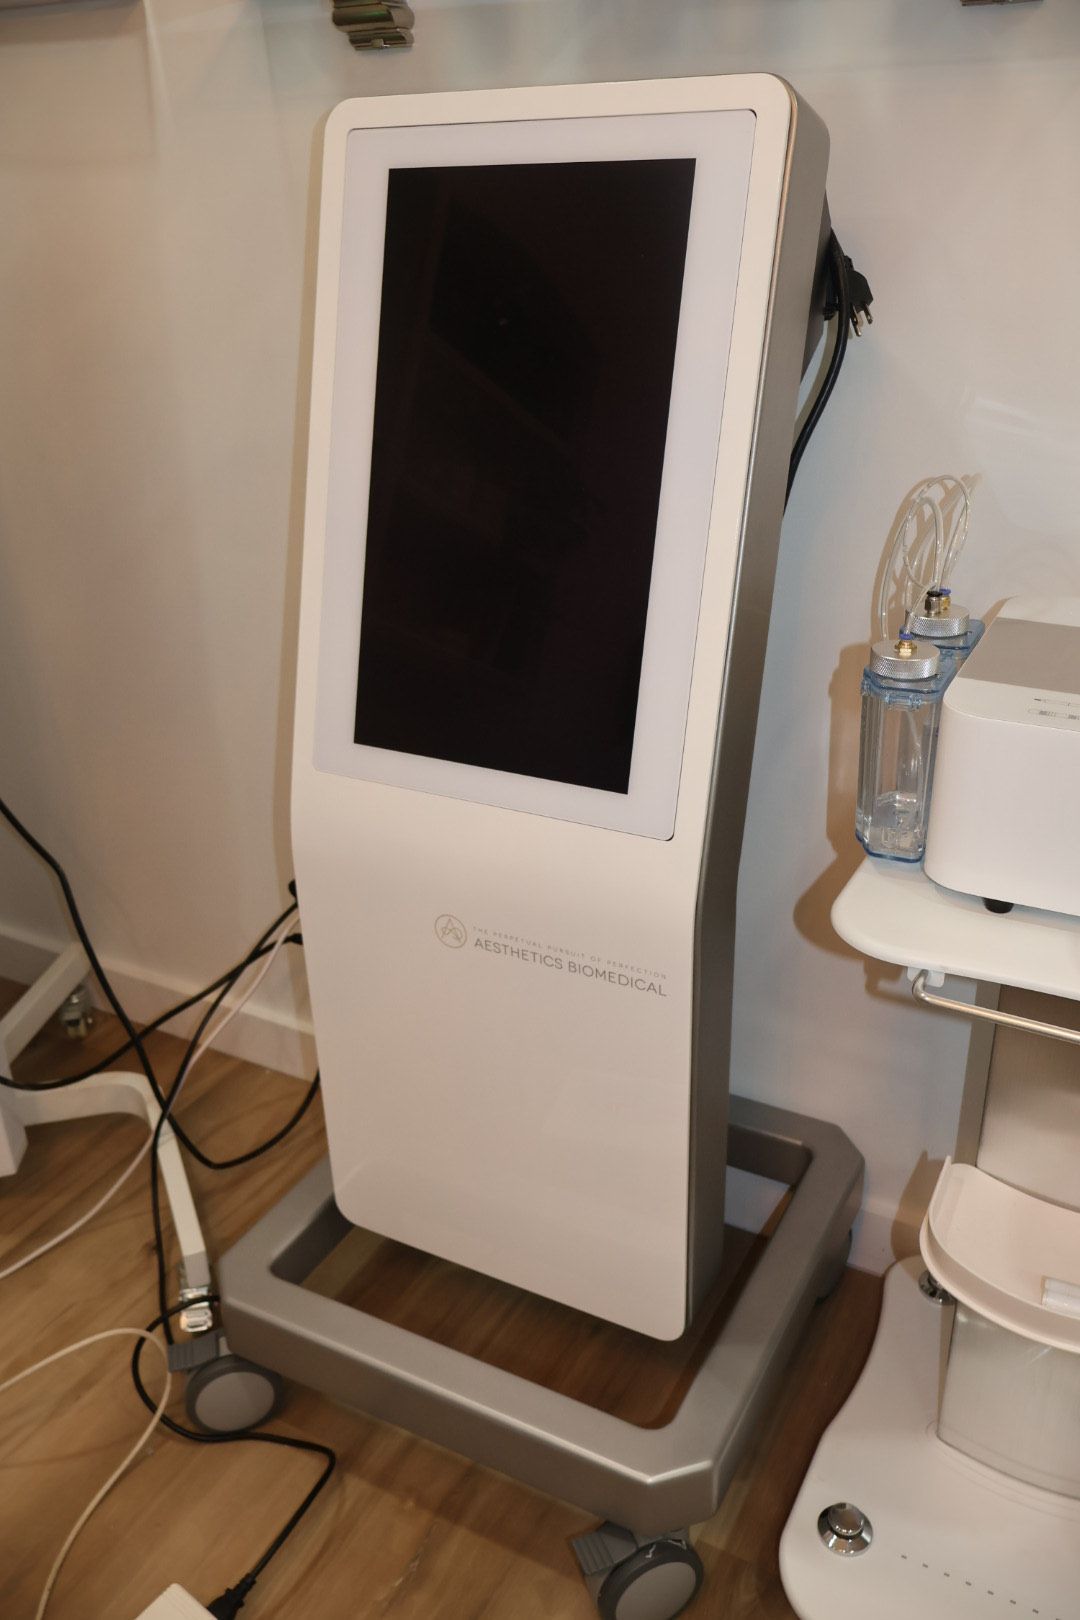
780;1260;1080;1620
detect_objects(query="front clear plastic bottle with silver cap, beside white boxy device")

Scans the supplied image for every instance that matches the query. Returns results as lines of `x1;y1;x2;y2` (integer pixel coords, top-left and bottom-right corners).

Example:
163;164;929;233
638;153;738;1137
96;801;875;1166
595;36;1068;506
855;630;955;862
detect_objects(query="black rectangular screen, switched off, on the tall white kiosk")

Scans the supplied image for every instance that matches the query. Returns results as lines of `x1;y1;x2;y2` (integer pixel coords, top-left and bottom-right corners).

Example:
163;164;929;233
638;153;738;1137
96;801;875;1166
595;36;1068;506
354;159;695;792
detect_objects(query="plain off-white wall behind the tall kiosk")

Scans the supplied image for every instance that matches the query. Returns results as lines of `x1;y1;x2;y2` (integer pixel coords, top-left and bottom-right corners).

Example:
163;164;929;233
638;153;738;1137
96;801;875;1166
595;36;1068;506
0;0;1080;1264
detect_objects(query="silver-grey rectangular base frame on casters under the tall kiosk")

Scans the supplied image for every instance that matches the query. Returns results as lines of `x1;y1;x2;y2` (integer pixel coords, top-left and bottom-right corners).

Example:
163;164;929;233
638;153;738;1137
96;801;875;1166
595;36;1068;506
219;1097;863;1541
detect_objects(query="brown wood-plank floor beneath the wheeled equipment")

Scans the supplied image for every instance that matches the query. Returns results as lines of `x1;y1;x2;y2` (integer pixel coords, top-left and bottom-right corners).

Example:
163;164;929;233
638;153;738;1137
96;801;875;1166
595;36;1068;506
0;987;881;1620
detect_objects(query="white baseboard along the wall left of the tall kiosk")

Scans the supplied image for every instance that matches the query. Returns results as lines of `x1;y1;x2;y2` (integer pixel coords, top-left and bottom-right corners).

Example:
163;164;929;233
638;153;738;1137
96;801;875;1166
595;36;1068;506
0;923;316;1079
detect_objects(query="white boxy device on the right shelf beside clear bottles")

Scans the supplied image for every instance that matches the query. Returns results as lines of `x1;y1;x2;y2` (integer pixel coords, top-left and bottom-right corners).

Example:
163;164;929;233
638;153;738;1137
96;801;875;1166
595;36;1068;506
925;596;1080;917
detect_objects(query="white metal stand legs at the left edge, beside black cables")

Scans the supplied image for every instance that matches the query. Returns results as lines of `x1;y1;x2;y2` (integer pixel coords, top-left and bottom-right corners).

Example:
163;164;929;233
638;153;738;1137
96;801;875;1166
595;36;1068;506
0;944;210;1332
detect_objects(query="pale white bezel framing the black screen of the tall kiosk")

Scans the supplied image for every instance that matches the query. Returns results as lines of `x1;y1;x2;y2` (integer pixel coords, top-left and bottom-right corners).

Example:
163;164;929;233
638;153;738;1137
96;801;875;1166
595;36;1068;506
314;109;756;839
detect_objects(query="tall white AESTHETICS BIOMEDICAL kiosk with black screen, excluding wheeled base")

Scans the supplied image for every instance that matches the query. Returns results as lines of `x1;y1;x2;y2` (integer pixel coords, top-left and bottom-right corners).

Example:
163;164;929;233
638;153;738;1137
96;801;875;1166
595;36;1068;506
293;76;827;1338
